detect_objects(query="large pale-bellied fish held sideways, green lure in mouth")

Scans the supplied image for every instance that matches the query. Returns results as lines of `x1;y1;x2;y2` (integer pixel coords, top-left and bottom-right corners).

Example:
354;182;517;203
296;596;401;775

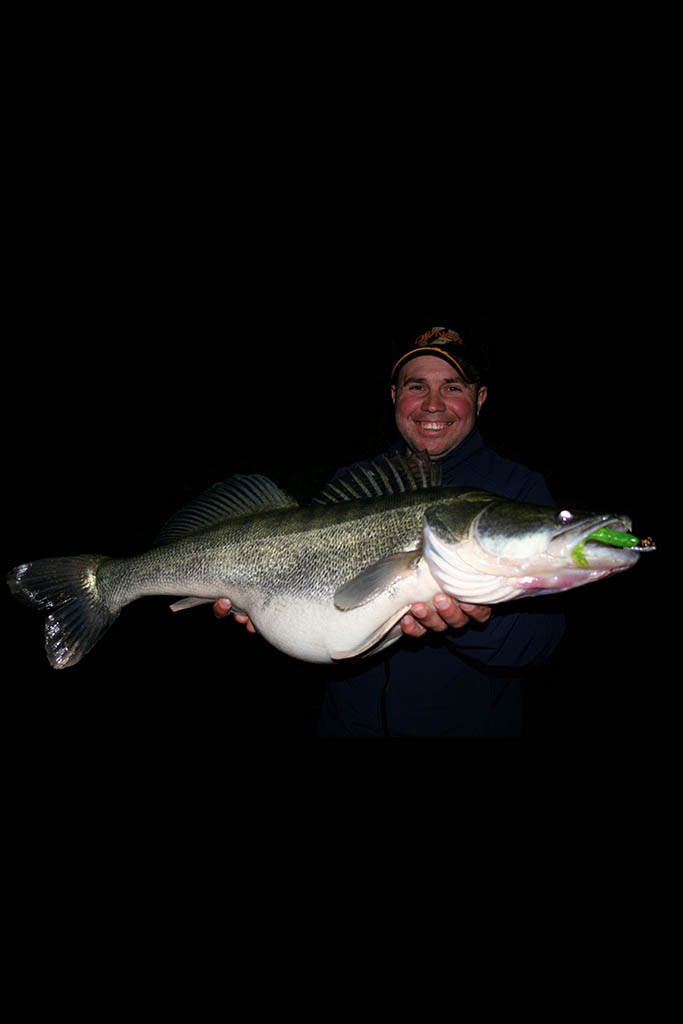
7;458;653;669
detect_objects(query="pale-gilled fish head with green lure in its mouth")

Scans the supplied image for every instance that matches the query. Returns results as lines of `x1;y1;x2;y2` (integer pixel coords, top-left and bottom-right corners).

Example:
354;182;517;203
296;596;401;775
425;493;653;604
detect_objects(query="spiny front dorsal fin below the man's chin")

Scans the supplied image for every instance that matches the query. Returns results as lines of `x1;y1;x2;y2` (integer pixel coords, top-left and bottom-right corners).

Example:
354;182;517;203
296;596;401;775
313;452;441;505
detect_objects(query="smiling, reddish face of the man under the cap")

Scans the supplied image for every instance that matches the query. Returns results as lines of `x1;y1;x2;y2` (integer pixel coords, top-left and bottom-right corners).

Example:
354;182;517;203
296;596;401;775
391;355;486;459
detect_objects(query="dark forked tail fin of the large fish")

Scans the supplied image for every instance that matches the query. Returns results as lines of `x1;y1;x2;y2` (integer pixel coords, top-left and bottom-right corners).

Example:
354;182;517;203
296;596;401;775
7;555;120;669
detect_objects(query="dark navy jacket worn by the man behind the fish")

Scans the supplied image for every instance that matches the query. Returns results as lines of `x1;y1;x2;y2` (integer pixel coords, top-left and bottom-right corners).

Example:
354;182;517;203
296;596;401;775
318;430;564;736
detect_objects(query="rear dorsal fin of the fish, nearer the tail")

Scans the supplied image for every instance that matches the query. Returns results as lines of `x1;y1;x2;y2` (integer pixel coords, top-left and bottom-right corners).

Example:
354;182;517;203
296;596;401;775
155;475;298;544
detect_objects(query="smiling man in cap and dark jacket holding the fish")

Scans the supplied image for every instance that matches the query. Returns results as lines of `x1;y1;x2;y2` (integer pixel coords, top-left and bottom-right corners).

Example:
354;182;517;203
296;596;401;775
214;328;564;736
